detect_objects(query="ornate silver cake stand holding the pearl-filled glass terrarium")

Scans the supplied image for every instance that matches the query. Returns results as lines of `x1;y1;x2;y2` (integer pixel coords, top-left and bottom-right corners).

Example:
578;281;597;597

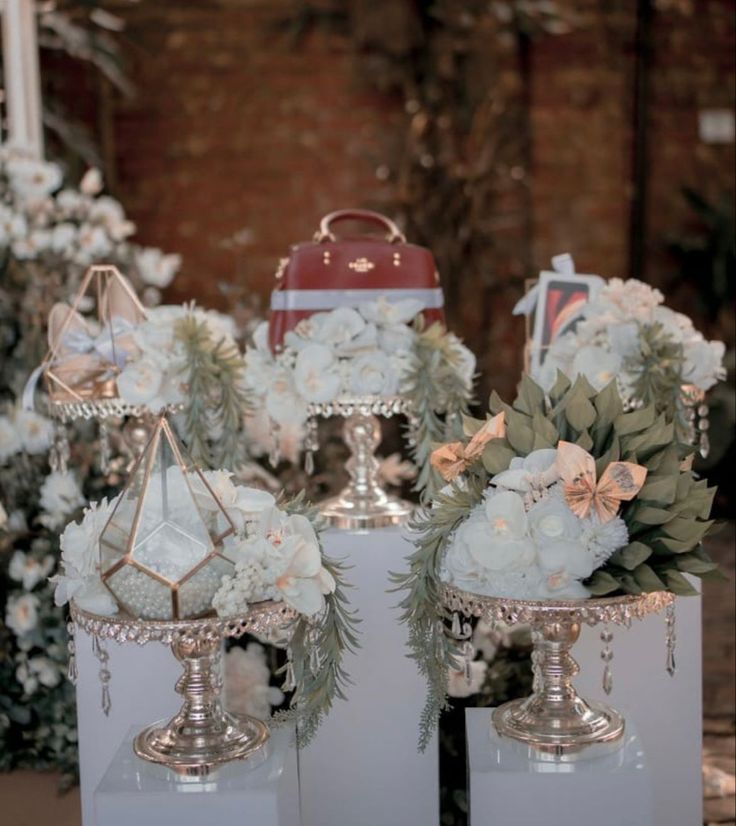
70;601;297;776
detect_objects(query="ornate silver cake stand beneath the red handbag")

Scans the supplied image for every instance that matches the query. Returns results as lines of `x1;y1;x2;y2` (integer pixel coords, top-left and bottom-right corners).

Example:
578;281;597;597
305;396;414;530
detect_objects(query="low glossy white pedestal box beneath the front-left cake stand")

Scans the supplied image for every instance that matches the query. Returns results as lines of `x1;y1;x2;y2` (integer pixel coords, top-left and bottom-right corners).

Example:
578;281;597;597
94;724;300;826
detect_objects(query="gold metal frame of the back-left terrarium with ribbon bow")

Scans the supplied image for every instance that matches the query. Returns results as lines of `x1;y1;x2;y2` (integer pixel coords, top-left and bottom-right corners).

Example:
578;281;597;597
43;264;147;402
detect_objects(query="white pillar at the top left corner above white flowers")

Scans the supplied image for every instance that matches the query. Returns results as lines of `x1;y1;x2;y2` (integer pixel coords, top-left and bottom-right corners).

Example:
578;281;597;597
0;0;43;158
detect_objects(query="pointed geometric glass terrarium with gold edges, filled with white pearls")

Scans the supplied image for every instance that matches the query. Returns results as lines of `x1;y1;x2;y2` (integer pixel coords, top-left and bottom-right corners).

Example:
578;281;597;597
100;415;235;620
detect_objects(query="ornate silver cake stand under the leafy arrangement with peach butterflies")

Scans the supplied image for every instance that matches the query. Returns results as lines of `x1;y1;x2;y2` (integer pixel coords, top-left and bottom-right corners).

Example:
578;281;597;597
441;585;675;762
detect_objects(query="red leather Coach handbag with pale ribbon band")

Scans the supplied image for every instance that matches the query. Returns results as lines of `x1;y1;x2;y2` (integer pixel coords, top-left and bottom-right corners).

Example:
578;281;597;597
269;209;445;352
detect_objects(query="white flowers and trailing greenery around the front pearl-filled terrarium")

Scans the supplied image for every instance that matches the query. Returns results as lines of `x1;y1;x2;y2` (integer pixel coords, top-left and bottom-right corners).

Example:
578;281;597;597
52;480;357;743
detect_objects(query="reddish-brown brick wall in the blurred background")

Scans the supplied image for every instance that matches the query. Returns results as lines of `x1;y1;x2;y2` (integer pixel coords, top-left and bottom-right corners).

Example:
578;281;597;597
47;0;734;392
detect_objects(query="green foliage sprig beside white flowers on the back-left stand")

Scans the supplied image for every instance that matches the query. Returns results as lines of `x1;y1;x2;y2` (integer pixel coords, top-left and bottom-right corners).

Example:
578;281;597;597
175;314;250;469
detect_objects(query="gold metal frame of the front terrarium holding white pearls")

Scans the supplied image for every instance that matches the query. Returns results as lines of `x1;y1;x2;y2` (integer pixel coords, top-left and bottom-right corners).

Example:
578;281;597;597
99;414;235;620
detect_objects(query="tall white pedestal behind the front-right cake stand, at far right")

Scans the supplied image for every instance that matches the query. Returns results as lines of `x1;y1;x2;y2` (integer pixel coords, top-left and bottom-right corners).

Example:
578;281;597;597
572;581;703;826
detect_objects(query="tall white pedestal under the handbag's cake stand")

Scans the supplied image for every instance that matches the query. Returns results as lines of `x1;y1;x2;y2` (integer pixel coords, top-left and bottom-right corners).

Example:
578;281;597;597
299;528;439;826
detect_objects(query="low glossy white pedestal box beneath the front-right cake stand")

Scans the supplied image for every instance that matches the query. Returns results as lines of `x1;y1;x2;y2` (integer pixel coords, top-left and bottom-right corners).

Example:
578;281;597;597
465;708;652;826
